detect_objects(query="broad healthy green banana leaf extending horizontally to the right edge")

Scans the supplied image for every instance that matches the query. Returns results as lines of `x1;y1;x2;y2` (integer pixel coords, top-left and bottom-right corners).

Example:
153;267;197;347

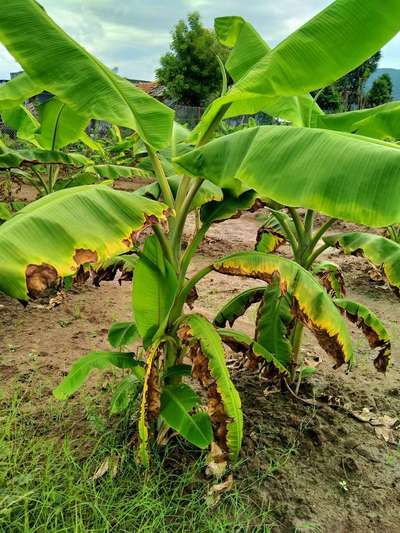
175;126;400;227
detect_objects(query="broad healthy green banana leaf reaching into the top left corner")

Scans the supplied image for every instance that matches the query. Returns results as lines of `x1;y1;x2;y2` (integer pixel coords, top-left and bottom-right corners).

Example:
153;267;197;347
0;0;173;149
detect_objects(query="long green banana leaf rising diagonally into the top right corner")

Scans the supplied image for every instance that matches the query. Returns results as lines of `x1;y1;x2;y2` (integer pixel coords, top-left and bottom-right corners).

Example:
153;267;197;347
195;0;400;138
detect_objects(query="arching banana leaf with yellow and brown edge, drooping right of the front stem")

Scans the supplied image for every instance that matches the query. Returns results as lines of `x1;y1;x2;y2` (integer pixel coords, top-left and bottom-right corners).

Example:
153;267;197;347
213;252;353;367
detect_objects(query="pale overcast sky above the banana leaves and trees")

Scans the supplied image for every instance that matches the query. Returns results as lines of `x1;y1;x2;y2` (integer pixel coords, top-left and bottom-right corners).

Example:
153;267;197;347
0;0;400;80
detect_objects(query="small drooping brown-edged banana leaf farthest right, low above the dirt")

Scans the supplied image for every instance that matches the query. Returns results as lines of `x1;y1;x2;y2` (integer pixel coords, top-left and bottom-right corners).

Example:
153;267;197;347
334;298;392;372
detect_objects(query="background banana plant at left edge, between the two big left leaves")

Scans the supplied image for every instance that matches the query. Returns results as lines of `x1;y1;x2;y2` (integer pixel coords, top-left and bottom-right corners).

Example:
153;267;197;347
0;95;152;196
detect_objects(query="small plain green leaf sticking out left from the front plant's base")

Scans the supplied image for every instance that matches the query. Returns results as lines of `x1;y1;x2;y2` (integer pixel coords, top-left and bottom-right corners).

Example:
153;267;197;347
53;352;143;400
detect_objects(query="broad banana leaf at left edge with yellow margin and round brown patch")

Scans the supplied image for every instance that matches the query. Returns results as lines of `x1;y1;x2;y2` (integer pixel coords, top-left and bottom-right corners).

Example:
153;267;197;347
0;185;167;300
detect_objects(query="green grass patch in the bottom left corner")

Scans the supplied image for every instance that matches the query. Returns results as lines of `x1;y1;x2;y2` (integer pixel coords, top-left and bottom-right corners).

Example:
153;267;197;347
0;386;272;533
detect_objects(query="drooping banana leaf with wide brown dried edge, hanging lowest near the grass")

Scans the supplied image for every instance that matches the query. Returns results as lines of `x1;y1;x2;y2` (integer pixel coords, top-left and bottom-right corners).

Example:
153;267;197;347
178;315;243;459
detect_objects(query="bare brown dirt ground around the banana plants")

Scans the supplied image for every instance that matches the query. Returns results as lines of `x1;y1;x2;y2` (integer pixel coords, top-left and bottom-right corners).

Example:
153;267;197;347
0;201;400;533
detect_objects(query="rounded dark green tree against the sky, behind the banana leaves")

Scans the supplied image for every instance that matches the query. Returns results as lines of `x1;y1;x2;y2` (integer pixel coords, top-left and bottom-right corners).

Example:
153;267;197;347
156;12;228;106
